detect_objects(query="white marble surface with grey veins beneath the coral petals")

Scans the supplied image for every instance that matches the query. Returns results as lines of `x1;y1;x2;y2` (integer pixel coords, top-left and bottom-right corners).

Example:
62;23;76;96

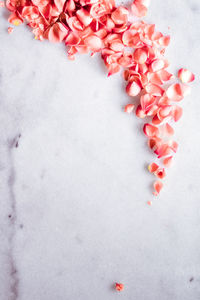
0;0;200;300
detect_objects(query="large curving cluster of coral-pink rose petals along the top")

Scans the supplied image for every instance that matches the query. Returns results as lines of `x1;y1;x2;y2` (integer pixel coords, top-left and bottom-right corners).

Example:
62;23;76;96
5;0;195;196
